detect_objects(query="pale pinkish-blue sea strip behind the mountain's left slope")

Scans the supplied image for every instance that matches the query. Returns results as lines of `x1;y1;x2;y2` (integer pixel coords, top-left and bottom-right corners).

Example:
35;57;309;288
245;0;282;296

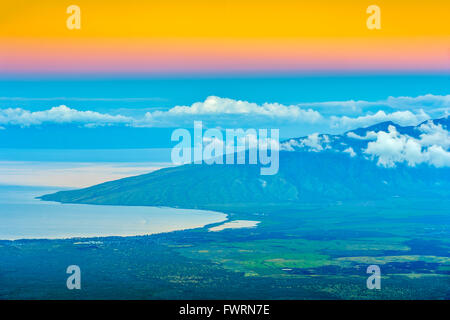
0;148;173;190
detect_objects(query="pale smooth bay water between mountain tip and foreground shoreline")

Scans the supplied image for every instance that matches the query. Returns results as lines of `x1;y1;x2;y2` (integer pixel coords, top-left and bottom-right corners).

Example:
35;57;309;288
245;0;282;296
0;186;226;240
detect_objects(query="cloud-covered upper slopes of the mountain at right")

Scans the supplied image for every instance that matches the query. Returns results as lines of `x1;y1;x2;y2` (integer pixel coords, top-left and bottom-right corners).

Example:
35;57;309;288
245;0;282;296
280;117;450;168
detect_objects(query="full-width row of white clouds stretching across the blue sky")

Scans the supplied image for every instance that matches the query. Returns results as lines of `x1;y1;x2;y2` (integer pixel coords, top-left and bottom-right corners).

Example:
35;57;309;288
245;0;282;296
0;94;450;132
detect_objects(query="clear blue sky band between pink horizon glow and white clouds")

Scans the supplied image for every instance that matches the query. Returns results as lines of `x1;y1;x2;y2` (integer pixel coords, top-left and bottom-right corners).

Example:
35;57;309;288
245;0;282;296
0;74;450;112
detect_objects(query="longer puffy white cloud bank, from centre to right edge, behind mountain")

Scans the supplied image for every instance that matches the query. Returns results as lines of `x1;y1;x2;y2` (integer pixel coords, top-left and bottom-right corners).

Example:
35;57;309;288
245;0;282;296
144;95;450;129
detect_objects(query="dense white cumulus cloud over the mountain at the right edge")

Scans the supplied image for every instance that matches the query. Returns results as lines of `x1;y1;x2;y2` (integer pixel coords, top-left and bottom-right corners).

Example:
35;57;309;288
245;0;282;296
364;124;450;167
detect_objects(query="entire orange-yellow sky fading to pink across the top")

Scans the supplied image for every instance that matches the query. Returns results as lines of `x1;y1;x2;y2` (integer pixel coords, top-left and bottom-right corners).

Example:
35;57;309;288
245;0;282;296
0;0;450;73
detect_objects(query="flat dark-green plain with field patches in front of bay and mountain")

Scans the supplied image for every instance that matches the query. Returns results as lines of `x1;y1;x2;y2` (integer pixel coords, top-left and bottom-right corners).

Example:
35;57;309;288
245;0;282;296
0;198;450;299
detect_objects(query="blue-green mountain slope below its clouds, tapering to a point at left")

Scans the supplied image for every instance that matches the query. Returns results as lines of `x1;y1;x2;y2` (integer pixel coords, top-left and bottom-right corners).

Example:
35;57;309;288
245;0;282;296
40;152;450;209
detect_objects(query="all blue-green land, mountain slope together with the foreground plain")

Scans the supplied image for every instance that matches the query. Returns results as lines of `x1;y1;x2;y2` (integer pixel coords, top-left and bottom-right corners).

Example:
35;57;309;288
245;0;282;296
5;121;450;299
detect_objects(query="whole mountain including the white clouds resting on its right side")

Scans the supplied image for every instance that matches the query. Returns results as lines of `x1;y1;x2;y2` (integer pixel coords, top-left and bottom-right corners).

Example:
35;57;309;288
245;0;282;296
40;117;450;209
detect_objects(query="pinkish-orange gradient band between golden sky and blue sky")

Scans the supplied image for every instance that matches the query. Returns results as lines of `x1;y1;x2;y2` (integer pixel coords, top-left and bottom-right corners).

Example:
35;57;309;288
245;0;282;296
0;37;450;73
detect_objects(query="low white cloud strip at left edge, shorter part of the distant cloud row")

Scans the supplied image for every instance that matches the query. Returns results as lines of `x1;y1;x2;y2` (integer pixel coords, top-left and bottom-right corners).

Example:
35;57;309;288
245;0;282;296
0;105;131;126
